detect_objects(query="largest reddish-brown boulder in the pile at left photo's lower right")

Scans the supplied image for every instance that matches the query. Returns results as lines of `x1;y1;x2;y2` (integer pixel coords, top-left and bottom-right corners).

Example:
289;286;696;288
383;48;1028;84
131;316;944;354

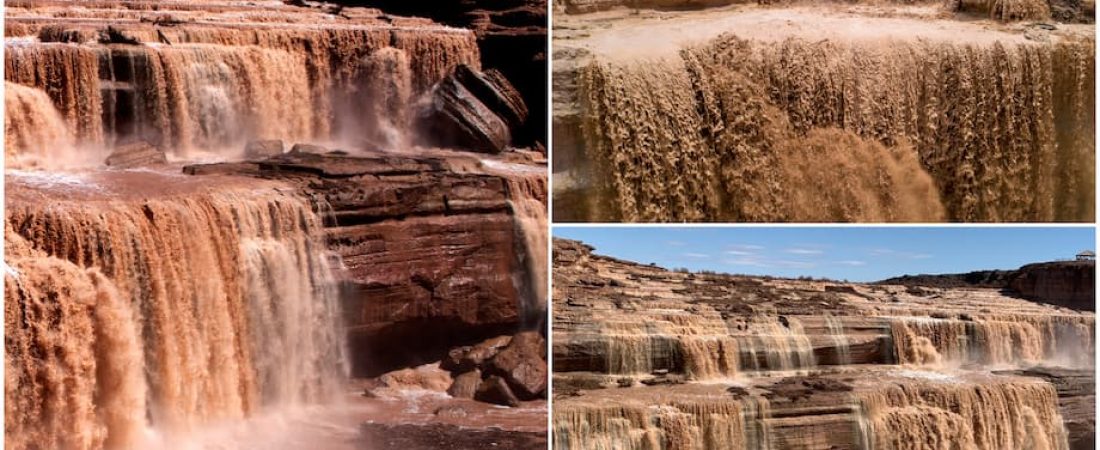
485;331;548;400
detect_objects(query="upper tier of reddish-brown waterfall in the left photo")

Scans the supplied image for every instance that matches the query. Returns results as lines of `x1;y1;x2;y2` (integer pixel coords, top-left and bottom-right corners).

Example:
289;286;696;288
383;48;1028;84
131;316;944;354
4;19;480;163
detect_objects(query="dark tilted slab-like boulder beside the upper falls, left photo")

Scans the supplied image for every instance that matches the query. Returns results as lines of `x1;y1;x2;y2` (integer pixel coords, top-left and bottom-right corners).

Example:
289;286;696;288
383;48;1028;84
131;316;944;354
419;65;527;153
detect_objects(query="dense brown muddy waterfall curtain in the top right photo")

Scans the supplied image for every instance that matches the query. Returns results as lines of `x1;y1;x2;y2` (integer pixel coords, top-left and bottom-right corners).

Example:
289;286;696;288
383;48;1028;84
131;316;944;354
575;35;1095;222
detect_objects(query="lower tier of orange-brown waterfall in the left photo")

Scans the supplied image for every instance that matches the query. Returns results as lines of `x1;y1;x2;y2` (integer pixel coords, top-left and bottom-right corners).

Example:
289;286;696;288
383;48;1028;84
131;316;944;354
6;189;347;449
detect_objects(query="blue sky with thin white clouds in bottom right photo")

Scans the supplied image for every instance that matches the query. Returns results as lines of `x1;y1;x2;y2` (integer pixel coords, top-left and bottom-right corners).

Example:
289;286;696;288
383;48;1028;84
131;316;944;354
553;226;1096;282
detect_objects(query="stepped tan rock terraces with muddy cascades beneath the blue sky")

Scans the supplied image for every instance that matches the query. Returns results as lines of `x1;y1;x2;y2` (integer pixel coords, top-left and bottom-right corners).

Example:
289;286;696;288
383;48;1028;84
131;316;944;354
551;236;1095;449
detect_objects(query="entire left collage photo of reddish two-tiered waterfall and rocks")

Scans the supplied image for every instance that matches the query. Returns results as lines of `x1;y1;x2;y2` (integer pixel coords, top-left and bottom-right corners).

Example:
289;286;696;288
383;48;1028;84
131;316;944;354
4;0;549;450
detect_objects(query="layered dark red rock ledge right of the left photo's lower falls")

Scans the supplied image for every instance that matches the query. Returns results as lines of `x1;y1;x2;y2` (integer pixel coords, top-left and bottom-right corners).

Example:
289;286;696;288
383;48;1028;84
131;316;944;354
185;153;546;376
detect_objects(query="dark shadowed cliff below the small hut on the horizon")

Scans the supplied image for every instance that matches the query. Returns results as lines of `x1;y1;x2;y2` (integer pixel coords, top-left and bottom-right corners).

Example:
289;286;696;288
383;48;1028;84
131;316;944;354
1008;261;1096;311
